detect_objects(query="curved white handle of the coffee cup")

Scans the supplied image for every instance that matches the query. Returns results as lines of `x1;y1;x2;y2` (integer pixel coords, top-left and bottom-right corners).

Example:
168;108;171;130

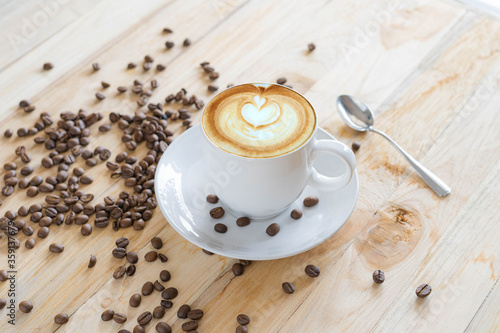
309;140;356;191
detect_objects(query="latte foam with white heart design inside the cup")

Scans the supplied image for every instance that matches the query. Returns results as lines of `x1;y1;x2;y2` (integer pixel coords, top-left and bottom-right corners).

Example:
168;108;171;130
202;84;316;158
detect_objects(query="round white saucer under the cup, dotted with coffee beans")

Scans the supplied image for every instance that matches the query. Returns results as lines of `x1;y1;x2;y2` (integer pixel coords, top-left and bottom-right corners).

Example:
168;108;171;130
155;126;358;260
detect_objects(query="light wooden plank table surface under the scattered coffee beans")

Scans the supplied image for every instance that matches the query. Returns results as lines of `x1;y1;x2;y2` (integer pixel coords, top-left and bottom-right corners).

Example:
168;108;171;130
0;0;500;332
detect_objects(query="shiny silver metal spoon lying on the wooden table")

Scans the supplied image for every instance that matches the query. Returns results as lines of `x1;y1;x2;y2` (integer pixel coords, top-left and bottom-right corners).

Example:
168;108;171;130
337;95;451;197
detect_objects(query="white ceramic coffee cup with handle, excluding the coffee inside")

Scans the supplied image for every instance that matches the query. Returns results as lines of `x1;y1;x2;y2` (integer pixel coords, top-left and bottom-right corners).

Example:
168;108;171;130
199;82;356;219
